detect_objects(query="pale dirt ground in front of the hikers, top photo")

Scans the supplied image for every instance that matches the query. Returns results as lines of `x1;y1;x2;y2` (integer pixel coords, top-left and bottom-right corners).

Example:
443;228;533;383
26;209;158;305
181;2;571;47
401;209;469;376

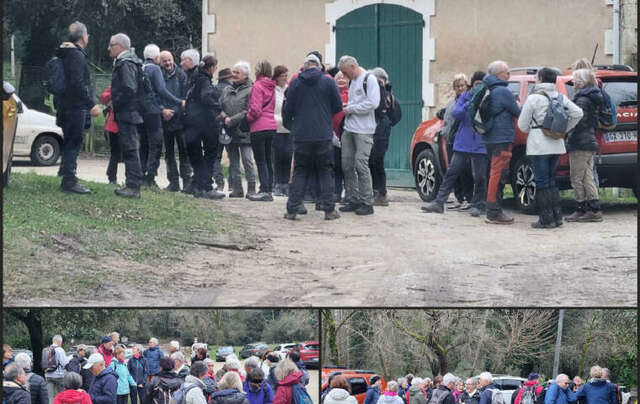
15;160;637;307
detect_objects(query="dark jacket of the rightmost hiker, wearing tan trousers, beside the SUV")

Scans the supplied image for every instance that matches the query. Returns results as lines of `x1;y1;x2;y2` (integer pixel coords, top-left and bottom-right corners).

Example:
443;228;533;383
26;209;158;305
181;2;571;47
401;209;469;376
567;87;602;151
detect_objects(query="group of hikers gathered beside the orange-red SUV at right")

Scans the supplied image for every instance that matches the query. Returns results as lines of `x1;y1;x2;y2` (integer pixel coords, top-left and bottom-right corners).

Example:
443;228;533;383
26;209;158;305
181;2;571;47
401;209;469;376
422;59;615;228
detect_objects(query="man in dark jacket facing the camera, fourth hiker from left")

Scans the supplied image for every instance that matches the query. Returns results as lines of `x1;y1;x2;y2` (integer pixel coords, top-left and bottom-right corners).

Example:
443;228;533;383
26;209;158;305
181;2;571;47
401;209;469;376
160;51;193;192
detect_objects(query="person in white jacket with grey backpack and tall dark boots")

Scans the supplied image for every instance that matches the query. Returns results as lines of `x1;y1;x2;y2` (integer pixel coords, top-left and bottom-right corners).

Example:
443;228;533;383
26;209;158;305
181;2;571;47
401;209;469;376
518;67;582;228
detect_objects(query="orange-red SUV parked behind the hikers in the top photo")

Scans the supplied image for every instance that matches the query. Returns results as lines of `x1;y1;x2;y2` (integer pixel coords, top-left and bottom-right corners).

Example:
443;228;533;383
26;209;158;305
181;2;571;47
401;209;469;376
409;65;638;213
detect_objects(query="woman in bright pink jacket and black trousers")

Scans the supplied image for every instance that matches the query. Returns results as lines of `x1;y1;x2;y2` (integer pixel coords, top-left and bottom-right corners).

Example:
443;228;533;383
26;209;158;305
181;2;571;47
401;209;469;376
247;60;277;201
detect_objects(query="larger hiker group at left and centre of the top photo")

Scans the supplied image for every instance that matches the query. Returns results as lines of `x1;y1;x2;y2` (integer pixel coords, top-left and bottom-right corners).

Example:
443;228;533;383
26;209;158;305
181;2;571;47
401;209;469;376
45;22;401;220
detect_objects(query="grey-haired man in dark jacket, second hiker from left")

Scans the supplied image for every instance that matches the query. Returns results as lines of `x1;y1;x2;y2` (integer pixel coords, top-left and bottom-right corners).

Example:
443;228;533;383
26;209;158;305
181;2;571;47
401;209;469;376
109;33;144;198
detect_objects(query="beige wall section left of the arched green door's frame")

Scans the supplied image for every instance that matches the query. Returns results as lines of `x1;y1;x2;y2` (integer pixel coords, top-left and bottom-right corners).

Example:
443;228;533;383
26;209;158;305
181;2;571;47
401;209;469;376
205;0;329;77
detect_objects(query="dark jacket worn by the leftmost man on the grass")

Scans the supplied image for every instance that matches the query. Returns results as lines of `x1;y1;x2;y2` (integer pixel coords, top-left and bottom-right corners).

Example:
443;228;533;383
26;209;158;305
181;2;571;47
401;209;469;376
55;42;96;110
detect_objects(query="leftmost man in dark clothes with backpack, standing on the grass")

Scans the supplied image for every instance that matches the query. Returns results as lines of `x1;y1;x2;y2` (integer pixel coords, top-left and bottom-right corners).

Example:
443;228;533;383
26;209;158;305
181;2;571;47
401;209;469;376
54;21;100;194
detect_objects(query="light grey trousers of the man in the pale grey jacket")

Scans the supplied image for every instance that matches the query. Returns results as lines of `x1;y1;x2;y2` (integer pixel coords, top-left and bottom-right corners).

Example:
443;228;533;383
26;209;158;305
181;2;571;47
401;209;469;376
341;130;373;206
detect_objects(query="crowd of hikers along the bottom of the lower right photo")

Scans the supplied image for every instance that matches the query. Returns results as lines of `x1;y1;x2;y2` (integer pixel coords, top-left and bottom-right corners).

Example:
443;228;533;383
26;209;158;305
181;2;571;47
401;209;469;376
322;366;626;404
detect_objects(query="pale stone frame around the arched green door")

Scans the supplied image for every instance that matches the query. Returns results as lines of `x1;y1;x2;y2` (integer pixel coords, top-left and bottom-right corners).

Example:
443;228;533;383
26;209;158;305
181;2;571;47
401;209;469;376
324;0;436;121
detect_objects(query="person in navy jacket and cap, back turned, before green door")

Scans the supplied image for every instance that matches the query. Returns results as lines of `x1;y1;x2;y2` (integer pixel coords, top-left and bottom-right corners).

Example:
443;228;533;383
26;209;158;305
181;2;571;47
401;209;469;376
282;53;342;220
